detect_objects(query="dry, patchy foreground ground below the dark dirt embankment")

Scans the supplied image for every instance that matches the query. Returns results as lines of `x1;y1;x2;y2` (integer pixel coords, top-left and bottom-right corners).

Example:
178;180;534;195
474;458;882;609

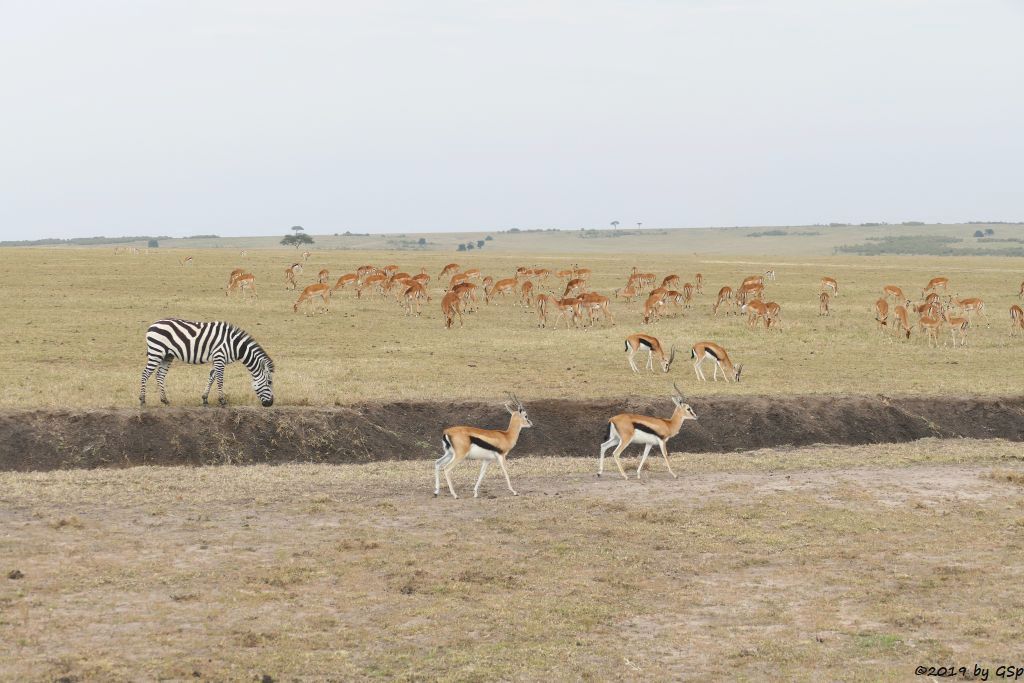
0;439;1024;681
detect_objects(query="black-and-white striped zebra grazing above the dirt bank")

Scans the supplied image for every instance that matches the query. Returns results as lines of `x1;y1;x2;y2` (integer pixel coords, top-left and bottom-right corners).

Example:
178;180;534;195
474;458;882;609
138;318;273;408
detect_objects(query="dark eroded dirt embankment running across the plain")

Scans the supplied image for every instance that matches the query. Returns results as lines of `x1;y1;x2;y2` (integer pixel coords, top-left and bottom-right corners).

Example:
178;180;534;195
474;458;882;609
0;395;1024;471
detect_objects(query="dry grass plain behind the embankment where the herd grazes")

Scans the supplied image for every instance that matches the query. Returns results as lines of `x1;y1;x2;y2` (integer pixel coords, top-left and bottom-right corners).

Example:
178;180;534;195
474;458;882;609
0;242;1024;410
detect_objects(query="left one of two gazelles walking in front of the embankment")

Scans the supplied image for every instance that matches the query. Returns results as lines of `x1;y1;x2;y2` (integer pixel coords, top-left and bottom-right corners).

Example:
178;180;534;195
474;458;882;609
434;394;534;498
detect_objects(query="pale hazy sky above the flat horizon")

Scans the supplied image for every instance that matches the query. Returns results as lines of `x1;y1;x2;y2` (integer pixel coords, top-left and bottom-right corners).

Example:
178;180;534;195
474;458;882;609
0;0;1024;239
